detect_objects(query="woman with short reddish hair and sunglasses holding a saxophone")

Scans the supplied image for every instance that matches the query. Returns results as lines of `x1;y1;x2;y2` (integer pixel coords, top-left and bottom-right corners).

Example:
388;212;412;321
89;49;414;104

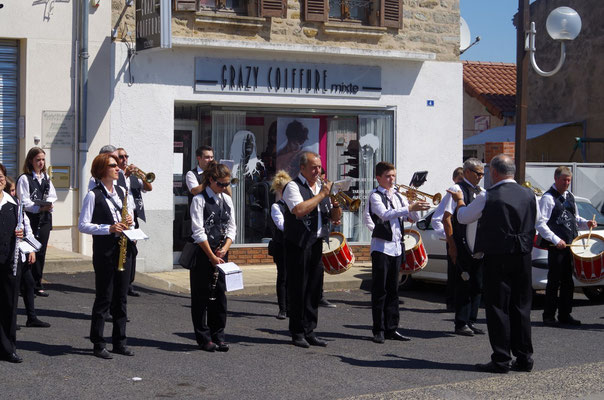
78;153;134;359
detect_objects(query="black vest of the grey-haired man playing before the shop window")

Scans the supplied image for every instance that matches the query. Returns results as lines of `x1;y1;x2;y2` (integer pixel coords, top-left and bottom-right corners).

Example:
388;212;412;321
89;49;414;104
283;177;330;248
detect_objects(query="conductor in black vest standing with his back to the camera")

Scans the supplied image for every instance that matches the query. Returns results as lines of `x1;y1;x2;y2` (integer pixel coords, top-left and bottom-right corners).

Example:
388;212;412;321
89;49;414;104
449;154;539;373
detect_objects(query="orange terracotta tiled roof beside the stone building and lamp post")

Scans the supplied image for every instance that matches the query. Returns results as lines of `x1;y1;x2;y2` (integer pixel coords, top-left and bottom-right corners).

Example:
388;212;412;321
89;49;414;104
462;61;516;118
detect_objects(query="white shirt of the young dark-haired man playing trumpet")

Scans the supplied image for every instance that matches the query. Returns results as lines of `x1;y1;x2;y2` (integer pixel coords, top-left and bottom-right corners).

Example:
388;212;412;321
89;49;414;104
363;186;420;257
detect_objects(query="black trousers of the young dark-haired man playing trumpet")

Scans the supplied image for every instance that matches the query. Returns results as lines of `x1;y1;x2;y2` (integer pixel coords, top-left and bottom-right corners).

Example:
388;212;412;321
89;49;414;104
371;251;403;335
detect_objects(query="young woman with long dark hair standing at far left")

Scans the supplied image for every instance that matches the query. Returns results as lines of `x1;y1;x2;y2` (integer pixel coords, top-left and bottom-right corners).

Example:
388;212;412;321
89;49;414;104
17;147;57;297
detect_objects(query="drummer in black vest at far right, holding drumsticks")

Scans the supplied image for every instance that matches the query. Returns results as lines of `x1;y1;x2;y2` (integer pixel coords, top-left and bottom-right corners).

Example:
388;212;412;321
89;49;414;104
537;166;597;326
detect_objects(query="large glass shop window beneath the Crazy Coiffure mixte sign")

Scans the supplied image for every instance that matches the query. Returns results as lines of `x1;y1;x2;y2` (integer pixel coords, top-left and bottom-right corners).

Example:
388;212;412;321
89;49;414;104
174;105;394;247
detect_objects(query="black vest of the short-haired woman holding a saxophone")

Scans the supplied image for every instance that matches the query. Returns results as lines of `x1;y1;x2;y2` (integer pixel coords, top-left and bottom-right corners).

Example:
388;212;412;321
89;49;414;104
90;184;128;259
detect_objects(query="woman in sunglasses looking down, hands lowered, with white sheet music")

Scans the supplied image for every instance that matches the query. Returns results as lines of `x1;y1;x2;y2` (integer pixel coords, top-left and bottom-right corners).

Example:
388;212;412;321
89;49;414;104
190;161;237;352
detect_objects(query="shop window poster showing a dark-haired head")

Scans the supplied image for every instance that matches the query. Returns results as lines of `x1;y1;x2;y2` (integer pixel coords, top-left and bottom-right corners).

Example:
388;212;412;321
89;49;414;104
277;117;320;178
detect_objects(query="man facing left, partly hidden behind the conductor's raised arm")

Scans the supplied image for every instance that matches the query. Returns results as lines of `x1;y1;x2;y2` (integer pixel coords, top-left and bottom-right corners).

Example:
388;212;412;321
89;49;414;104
432;158;484;336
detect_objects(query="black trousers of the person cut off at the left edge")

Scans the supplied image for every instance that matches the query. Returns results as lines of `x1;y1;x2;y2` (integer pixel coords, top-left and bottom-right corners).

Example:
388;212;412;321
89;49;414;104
0;258;21;357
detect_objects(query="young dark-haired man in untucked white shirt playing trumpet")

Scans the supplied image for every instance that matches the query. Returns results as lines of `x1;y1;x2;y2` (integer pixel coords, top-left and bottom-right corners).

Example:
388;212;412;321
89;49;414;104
365;161;430;343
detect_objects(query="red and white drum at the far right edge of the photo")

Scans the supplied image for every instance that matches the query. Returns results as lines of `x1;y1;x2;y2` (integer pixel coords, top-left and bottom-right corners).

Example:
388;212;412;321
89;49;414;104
570;234;604;283
